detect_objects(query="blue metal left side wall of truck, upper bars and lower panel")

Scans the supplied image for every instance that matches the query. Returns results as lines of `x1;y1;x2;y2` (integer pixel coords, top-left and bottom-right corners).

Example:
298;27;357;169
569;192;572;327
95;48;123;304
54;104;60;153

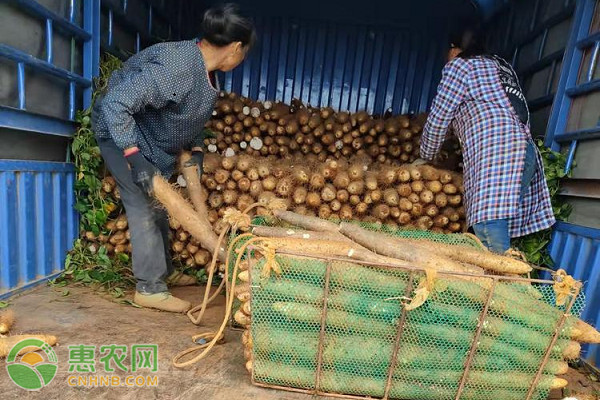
0;0;180;297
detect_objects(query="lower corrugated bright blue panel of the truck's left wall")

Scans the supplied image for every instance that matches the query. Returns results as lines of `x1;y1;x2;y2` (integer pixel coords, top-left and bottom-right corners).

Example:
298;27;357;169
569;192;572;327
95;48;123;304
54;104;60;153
0;160;78;296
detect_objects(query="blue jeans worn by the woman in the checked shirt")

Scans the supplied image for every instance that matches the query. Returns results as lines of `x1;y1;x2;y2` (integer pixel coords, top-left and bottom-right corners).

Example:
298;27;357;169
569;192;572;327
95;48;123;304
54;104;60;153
473;141;537;254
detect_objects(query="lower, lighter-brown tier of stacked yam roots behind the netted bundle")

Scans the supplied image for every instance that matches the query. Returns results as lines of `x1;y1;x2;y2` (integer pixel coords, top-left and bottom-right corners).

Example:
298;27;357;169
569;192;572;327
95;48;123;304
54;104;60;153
84;154;466;268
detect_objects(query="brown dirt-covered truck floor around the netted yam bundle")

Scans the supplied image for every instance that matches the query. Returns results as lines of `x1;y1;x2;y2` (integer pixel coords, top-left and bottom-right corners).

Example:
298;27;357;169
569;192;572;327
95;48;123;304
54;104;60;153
0;286;600;400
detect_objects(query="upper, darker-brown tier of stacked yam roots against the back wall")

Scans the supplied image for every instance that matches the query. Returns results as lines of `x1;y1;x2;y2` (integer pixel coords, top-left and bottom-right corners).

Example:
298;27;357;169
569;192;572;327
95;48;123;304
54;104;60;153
205;93;460;165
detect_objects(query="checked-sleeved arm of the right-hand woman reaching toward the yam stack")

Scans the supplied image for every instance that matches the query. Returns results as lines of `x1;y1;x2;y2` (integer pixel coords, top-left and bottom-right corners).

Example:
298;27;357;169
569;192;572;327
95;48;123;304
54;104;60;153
420;57;471;160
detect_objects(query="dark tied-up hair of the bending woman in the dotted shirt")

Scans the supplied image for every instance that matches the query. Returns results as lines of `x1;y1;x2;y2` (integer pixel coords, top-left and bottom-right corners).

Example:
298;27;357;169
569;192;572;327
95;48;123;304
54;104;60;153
201;3;256;47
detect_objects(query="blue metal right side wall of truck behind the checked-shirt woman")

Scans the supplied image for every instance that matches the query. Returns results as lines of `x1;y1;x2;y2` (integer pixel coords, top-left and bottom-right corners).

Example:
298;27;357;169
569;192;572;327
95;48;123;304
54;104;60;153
491;0;600;363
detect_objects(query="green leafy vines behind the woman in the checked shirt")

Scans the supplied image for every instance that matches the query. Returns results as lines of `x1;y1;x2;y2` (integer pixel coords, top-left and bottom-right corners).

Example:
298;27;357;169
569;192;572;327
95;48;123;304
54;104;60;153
512;140;572;267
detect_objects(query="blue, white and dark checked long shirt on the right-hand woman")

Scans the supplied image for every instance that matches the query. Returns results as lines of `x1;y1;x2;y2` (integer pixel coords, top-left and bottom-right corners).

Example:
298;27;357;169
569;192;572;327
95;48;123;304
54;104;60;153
421;57;555;237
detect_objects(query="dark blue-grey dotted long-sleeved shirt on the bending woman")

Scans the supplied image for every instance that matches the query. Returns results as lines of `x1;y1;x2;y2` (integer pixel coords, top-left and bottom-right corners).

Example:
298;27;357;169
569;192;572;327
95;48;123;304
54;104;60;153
92;40;218;176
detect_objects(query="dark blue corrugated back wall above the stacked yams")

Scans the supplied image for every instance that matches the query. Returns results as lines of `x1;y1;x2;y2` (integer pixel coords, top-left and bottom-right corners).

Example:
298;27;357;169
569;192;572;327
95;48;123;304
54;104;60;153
223;17;446;113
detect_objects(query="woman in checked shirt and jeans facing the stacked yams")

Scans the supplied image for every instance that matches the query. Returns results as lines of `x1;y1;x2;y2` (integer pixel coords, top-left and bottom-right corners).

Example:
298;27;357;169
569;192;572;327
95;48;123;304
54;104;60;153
421;29;555;253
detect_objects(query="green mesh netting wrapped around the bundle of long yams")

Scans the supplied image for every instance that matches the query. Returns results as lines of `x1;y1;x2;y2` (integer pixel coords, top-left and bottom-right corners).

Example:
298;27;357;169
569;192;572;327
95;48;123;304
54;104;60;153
240;220;583;400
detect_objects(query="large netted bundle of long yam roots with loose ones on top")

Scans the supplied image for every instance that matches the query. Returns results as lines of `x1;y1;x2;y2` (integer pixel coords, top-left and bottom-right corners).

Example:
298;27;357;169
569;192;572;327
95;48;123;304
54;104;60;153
227;211;600;399
